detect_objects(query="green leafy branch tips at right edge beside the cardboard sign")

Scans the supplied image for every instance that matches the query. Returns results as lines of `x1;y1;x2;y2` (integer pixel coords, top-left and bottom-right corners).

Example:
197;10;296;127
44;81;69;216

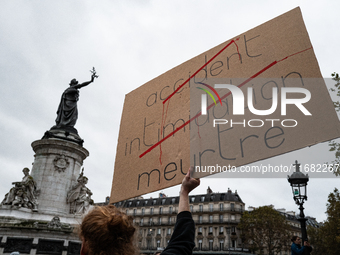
329;73;340;176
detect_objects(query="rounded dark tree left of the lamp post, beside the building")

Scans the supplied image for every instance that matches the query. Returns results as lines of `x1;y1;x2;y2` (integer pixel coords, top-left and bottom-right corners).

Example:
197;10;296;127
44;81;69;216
239;206;291;255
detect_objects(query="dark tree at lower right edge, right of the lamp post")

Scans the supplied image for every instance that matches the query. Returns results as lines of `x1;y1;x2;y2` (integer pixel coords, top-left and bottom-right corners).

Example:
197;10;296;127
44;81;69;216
308;188;340;255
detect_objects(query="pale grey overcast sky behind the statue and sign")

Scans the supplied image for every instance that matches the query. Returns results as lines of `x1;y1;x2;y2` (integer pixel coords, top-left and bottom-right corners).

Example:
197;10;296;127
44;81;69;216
0;0;340;221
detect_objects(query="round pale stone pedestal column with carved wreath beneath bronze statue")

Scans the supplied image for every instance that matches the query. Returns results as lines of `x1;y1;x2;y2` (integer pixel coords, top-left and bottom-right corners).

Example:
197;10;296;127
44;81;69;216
31;138;89;216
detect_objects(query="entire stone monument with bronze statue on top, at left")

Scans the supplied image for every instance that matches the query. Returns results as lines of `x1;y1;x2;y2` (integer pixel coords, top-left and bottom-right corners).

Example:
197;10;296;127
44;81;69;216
0;68;98;255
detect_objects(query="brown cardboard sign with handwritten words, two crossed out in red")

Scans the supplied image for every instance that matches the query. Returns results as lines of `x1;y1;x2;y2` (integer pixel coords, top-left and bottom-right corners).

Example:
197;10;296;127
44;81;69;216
110;8;340;203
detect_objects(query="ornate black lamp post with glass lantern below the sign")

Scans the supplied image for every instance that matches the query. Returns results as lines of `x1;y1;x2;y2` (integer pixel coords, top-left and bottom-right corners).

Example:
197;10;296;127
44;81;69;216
288;160;309;254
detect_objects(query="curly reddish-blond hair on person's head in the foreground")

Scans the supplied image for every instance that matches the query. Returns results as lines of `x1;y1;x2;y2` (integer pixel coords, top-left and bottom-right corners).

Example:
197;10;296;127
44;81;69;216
79;205;138;255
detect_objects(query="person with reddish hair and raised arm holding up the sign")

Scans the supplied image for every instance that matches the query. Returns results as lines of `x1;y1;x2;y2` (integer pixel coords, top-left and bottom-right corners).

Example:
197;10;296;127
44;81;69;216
80;167;200;255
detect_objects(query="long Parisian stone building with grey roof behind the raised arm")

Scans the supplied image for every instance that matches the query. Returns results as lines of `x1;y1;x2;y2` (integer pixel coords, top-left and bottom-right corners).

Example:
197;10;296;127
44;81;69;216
114;188;248;254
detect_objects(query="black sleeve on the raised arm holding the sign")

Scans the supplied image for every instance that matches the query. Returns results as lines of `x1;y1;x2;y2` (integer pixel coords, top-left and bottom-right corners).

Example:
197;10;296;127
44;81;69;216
161;211;195;255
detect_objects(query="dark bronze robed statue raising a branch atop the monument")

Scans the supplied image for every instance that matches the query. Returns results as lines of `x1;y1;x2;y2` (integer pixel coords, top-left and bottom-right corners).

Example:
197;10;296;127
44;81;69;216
54;67;98;130
